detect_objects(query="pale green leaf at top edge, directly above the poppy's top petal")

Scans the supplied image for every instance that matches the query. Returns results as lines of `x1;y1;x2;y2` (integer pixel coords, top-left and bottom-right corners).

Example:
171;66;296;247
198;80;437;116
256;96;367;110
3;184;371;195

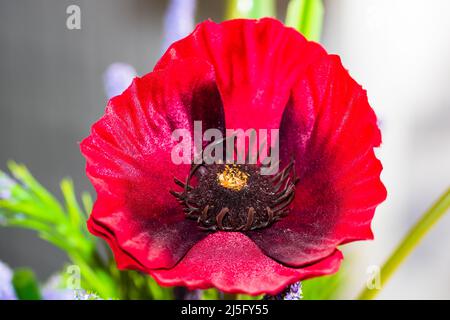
226;0;276;19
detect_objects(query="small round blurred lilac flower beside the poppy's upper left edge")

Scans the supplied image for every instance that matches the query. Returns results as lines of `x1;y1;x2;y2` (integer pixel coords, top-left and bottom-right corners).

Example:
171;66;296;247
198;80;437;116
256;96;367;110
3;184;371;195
103;62;137;99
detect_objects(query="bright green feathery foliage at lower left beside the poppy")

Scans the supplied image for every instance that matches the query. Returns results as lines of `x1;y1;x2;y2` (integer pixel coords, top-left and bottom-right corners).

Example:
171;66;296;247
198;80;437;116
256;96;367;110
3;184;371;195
0;162;199;300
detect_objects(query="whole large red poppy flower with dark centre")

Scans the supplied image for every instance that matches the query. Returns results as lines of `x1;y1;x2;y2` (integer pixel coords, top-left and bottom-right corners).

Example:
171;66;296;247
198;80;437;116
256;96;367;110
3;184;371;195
81;18;386;294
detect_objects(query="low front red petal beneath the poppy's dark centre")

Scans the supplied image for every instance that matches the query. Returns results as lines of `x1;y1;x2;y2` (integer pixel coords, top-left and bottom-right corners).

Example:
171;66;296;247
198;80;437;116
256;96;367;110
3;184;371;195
151;232;342;295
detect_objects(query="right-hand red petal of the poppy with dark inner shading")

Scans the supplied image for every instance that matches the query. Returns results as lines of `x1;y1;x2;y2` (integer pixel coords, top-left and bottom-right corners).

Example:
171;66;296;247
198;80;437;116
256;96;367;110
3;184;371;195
248;56;386;267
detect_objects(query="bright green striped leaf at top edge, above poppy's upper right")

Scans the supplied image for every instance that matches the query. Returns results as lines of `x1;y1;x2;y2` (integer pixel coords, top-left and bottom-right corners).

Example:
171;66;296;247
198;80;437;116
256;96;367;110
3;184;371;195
286;0;324;42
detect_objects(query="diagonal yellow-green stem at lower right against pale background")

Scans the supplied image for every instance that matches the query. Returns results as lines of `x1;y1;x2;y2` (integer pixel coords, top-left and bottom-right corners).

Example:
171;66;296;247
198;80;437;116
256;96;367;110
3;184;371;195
358;188;450;300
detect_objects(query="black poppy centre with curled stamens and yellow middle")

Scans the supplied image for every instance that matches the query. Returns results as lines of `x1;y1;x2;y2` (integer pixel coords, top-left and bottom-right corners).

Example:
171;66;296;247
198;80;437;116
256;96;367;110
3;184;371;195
171;161;297;231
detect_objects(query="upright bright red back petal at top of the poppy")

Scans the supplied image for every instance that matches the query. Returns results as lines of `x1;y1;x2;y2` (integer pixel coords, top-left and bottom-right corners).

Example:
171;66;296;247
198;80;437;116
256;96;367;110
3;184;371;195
155;18;325;129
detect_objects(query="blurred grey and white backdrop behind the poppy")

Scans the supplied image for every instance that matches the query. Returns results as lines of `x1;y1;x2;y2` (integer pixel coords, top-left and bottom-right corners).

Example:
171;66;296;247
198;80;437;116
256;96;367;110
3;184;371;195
0;0;450;299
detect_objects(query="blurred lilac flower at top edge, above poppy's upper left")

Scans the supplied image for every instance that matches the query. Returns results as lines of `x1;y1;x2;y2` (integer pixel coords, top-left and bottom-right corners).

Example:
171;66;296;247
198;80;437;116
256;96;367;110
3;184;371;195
163;0;197;51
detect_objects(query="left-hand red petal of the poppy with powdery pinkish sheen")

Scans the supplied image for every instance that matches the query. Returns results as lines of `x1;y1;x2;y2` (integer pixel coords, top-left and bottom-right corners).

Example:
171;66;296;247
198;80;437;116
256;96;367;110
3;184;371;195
81;60;224;268
